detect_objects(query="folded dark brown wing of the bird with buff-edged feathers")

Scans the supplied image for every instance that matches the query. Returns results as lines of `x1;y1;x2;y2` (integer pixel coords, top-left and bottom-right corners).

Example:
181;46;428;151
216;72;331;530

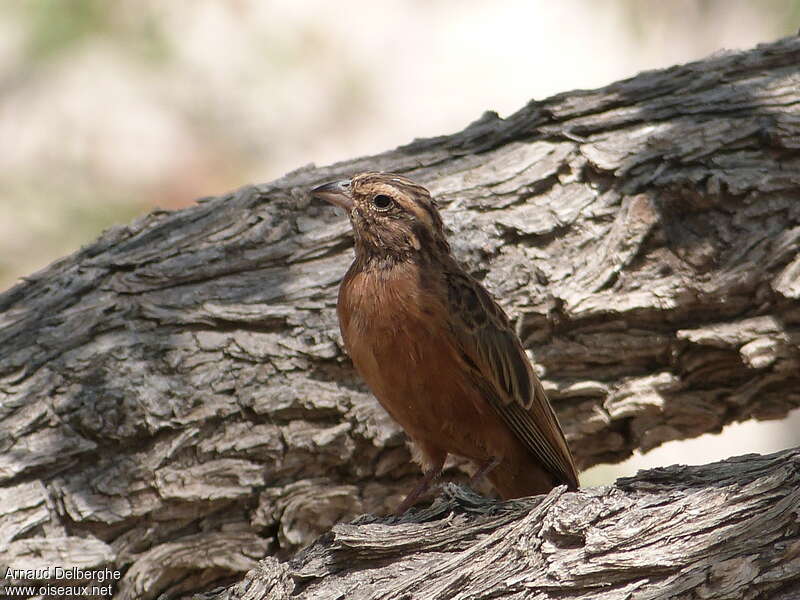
440;271;578;488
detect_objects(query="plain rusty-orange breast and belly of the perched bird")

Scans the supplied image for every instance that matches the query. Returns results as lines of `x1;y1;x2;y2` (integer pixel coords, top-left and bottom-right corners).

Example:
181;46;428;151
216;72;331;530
338;258;506;460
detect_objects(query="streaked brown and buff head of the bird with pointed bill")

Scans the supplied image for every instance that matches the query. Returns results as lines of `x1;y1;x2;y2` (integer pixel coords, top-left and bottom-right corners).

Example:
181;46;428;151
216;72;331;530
311;173;450;260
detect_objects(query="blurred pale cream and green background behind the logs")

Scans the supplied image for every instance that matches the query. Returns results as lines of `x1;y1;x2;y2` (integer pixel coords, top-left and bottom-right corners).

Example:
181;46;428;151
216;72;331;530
0;0;800;481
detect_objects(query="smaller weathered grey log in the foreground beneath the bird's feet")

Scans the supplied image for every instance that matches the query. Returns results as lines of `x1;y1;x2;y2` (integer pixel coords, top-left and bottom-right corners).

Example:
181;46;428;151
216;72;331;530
202;450;800;600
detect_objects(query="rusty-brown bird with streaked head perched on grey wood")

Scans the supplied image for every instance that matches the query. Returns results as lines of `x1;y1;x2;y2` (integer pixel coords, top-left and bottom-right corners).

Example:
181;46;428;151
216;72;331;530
312;173;578;514
